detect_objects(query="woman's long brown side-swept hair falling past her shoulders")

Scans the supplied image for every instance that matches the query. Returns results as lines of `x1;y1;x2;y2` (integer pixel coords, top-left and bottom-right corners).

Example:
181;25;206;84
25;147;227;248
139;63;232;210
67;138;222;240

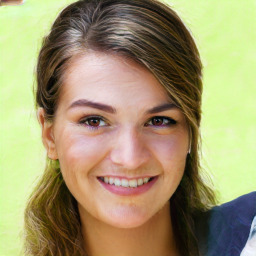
25;0;215;256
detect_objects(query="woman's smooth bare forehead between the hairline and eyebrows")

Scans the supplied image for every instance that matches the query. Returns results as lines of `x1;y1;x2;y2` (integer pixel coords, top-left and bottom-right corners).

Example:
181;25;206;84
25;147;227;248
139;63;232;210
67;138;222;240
61;52;170;107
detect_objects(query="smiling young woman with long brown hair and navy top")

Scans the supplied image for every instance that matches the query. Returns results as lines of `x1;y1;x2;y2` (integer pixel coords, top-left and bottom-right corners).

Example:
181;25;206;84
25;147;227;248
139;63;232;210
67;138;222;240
25;0;256;256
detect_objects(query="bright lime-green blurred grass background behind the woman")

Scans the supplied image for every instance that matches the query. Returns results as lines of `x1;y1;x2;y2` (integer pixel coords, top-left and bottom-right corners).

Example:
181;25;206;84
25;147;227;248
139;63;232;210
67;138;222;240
0;0;256;256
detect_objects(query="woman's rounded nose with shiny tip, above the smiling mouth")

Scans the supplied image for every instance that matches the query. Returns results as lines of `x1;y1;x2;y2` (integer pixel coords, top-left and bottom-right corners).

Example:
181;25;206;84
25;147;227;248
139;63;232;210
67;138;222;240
110;128;151;170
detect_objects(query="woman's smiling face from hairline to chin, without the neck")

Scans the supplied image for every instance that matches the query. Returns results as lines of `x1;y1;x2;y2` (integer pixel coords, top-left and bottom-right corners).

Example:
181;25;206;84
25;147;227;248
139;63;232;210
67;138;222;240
43;52;189;228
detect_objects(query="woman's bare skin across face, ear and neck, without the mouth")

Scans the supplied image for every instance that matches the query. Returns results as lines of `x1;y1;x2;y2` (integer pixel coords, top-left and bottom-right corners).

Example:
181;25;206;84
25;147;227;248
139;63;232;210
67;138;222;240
38;52;189;256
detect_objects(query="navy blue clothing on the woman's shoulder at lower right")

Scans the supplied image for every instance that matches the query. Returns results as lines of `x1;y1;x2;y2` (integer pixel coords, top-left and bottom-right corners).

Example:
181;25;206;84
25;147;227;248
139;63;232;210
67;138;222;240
196;192;256;256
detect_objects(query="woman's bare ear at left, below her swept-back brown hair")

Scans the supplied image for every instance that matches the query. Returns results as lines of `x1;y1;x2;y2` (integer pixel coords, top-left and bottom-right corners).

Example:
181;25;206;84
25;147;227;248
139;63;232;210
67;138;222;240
37;108;58;160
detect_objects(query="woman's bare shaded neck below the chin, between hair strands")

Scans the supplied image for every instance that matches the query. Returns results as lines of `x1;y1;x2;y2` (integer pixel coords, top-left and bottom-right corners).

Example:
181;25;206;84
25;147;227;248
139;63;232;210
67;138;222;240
80;202;178;256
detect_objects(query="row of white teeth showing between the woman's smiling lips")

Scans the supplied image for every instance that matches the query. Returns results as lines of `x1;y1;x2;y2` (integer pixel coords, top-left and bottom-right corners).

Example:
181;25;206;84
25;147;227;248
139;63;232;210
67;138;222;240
98;176;156;188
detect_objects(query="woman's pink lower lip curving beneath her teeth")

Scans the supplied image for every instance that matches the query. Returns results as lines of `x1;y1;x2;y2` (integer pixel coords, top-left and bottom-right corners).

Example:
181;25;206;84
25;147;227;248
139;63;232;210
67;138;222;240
98;176;158;196
